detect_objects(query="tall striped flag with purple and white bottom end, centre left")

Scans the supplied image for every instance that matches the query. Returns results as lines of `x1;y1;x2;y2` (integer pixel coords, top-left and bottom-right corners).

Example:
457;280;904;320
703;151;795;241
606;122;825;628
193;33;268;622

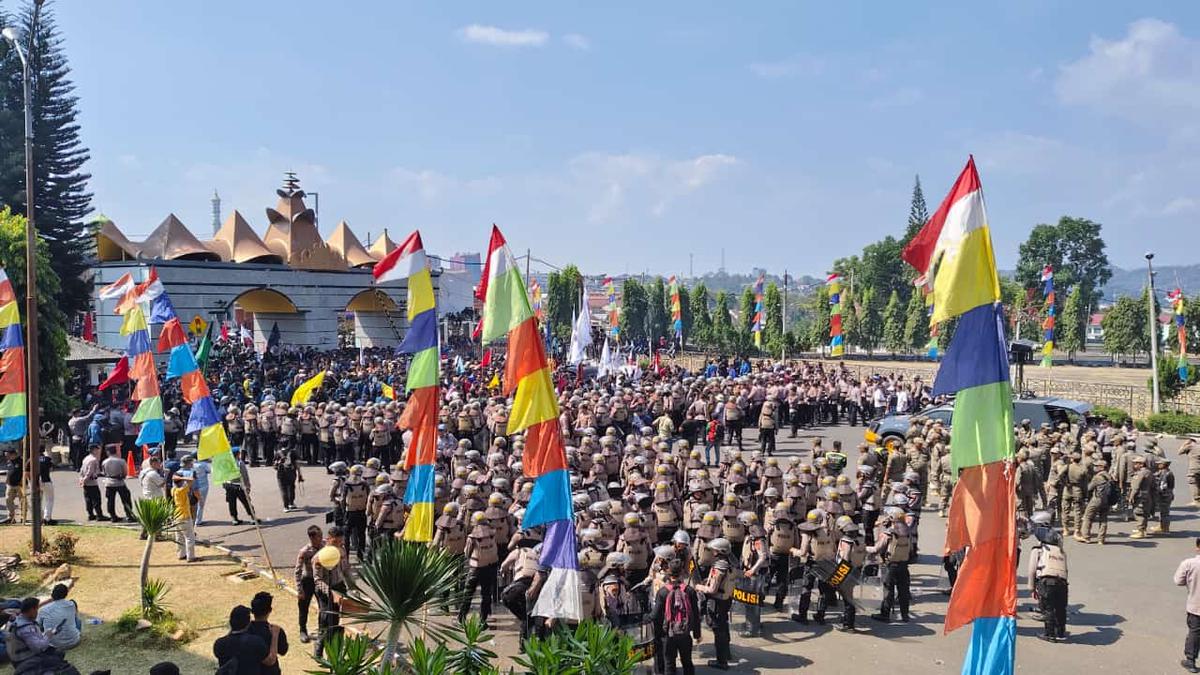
482;225;582;621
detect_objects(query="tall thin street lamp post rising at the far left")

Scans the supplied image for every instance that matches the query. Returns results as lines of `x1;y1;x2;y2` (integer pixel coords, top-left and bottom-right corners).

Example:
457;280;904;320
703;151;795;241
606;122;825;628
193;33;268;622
0;0;42;552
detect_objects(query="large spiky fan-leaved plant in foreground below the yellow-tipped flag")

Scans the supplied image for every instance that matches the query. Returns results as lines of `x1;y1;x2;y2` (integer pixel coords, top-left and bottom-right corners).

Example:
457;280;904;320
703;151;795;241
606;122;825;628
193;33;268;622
347;539;462;663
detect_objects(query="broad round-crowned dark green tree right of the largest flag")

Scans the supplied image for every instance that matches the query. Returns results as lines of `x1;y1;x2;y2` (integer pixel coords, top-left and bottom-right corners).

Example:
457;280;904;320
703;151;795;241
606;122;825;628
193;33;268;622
1013;216;1112;307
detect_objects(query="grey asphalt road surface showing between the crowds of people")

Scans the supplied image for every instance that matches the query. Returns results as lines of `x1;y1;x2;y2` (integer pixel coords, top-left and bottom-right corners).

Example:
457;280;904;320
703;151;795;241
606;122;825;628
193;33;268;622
30;426;1198;675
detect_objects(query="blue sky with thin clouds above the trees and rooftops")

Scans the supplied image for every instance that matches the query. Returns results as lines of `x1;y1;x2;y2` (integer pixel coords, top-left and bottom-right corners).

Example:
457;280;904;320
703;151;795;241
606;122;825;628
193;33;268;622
53;0;1200;274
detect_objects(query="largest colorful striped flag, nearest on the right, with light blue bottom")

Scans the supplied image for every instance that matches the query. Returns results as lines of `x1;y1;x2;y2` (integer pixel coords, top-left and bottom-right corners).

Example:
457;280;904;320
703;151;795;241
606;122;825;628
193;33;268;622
901;157;1016;675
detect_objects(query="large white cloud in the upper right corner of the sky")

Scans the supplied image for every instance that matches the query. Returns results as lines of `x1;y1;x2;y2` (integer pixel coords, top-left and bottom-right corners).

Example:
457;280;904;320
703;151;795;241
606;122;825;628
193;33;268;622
1055;18;1200;126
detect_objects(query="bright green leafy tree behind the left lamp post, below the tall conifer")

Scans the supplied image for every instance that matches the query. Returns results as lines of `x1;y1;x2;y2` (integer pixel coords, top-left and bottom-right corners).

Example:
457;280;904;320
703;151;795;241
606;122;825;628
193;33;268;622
0;207;72;417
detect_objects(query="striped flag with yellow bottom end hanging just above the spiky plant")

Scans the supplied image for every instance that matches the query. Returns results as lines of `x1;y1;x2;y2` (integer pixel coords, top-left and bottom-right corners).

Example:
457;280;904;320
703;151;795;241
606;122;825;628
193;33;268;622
372;231;439;542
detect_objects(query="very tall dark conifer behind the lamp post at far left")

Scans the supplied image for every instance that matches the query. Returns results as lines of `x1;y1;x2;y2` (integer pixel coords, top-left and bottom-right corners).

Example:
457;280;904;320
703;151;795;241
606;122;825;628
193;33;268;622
0;2;94;316
